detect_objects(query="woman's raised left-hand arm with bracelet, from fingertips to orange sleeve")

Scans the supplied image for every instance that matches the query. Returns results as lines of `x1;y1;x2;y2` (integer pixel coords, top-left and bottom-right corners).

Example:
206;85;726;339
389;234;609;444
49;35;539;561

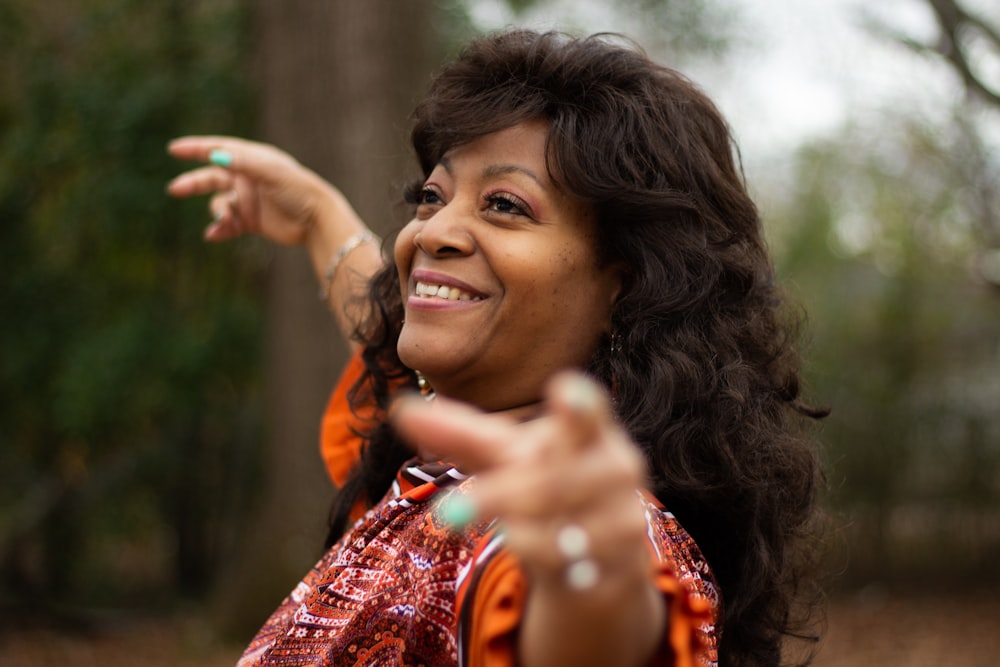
167;136;384;343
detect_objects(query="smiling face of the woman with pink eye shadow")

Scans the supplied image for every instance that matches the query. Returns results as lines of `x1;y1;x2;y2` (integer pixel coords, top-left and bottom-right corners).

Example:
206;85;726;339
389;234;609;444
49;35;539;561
395;121;621;410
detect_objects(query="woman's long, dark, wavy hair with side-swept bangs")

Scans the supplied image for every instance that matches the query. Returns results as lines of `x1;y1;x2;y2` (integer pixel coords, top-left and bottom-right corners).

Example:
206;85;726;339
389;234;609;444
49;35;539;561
330;30;825;666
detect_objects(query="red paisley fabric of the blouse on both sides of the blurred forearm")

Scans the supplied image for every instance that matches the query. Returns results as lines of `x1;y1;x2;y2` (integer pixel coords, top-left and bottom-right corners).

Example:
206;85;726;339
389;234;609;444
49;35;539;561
239;460;719;667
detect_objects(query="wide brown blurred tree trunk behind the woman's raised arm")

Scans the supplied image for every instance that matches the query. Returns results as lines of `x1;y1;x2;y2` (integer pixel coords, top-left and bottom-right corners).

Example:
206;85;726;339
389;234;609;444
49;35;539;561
212;0;439;635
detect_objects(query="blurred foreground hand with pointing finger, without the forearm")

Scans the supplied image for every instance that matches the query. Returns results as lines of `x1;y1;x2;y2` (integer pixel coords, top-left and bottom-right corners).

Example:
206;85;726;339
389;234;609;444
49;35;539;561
393;373;650;596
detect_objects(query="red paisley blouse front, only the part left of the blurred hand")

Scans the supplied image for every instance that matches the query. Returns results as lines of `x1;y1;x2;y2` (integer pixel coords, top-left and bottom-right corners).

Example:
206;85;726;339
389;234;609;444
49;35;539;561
239;461;485;667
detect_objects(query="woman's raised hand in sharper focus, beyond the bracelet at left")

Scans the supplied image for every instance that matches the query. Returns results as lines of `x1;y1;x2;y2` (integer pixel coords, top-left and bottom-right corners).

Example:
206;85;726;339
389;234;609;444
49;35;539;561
167;136;342;245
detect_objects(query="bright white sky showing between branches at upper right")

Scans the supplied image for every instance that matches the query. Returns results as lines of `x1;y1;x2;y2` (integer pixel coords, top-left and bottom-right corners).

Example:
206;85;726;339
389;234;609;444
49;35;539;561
473;0;984;163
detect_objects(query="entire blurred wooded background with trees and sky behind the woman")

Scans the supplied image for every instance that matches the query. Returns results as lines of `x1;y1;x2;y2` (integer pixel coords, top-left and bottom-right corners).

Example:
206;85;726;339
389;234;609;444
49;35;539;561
0;0;1000;667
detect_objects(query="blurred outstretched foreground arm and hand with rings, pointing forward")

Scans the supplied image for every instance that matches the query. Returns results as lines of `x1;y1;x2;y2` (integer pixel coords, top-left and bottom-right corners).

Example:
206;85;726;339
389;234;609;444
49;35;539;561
393;374;667;667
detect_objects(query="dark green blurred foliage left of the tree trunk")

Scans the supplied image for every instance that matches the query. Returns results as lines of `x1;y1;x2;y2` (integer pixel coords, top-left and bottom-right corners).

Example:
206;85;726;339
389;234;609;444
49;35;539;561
0;0;261;604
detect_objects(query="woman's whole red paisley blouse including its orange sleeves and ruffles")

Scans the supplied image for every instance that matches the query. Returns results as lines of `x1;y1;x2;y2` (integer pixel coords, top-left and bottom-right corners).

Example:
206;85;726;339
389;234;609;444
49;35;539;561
239;357;721;667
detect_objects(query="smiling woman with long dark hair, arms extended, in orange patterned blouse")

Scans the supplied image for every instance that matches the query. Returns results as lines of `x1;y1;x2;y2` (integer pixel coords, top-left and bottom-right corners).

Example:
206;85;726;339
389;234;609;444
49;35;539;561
170;31;821;665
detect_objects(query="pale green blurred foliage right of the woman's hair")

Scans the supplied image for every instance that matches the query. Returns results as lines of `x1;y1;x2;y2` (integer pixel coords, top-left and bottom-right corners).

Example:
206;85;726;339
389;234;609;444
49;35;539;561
777;110;1000;584
